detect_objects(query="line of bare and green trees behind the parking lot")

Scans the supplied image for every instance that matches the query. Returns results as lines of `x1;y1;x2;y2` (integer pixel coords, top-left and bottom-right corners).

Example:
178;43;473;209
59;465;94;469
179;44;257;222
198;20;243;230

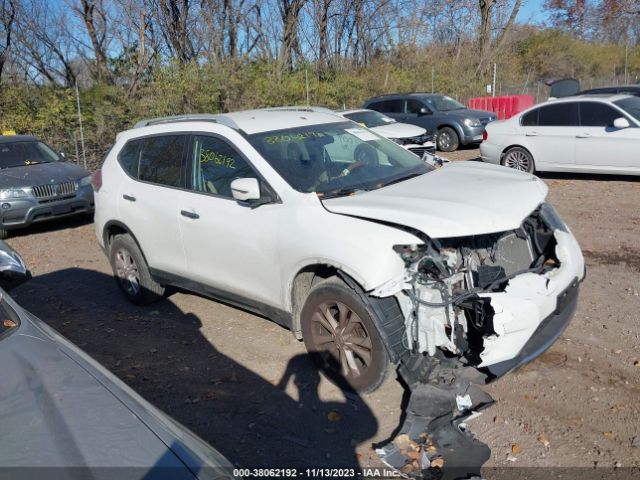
0;0;640;169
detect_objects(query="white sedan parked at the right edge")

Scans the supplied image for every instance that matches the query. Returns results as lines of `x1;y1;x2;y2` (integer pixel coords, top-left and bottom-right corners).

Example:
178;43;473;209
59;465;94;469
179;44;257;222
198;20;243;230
480;94;640;175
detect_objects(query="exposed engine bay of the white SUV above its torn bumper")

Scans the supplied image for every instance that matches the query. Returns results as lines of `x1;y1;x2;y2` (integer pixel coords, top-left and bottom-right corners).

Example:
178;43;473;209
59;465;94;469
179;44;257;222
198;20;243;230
372;204;560;372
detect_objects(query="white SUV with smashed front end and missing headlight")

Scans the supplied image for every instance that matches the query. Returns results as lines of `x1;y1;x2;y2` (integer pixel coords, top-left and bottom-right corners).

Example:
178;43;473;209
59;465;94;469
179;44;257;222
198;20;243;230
93;108;585;391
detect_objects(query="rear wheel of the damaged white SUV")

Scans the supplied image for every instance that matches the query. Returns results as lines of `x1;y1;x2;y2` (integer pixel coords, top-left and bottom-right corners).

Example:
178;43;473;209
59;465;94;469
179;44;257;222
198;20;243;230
109;234;164;305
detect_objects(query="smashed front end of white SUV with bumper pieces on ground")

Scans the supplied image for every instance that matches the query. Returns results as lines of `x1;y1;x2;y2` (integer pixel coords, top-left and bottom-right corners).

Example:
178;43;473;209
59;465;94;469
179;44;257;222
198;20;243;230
370;204;585;479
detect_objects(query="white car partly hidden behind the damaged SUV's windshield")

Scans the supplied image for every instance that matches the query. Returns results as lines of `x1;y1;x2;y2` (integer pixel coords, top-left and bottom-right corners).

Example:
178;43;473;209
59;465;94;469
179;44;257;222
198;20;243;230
338;109;436;157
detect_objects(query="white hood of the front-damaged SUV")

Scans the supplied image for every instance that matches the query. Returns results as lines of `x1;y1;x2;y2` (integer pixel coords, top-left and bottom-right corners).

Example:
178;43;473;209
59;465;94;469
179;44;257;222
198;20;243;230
322;162;548;238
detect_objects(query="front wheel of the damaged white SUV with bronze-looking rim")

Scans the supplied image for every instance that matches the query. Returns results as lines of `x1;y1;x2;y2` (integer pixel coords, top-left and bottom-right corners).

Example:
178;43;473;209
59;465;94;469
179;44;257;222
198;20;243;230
300;277;391;393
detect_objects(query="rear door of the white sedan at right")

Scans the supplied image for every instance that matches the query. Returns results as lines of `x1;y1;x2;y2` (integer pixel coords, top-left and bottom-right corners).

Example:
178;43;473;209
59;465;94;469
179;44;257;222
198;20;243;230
521;102;578;170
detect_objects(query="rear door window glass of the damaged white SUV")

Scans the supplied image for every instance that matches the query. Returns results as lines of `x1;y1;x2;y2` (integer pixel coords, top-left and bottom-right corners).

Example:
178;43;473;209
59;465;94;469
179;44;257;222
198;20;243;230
138;135;187;187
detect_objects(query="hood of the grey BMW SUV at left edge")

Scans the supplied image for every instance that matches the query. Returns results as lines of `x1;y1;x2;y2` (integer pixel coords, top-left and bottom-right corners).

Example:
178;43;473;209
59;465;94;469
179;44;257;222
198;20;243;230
0;162;89;188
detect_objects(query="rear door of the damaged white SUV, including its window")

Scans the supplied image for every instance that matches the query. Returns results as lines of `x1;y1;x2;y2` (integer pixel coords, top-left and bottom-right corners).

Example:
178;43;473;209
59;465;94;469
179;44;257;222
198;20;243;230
118;133;188;274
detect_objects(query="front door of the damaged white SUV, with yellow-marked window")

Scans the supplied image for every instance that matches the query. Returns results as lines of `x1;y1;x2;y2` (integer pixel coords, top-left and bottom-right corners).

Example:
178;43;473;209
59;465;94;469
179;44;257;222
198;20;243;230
178;134;282;313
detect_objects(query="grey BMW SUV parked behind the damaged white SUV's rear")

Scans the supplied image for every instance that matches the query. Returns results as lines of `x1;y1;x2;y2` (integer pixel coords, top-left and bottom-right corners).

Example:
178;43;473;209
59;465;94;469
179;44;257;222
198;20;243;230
0;135;94;238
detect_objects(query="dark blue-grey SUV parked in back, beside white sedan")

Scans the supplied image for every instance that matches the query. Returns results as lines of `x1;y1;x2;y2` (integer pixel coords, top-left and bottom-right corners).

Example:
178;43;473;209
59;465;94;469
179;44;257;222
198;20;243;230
364;93;497;152
